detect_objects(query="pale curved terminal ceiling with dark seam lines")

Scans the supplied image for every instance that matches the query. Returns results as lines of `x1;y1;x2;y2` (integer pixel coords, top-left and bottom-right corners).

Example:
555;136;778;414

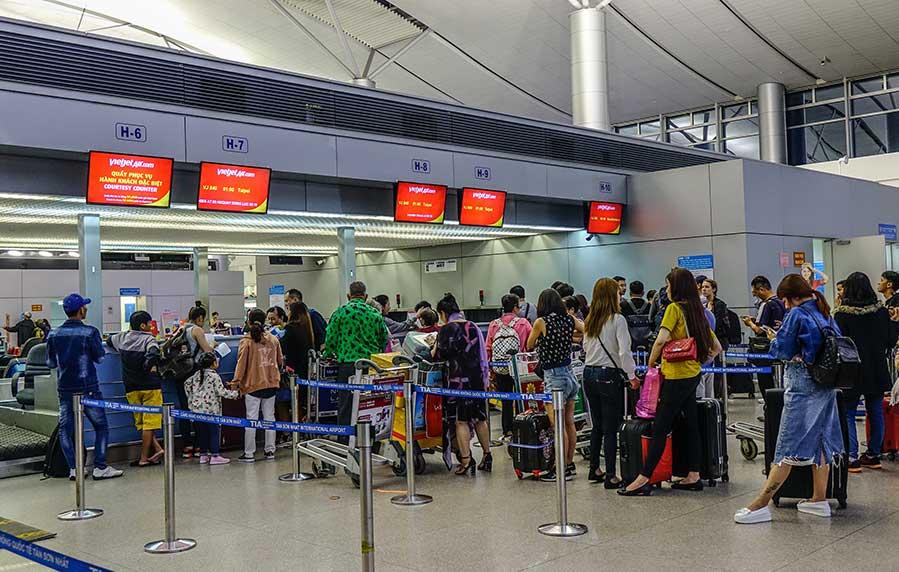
0;0;899;123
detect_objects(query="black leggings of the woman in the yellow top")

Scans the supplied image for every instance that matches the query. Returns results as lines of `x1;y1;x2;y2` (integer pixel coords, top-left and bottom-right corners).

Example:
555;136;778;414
641;375;701;478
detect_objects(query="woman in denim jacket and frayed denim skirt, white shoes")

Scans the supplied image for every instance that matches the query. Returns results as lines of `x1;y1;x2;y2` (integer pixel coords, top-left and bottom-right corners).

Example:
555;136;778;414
734;274;844;524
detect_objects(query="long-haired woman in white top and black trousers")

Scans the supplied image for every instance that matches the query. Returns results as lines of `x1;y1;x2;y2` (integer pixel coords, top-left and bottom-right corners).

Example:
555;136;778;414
584;278;639;489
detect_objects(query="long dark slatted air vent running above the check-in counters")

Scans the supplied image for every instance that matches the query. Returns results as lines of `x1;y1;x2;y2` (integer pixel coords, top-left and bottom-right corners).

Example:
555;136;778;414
0;31;724;171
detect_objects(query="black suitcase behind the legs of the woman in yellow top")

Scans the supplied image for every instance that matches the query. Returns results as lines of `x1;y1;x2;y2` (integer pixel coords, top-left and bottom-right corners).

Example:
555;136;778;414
671;398;730;487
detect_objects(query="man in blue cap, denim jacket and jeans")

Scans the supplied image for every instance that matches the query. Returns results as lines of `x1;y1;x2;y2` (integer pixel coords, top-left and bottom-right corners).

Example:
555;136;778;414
47;294;122;481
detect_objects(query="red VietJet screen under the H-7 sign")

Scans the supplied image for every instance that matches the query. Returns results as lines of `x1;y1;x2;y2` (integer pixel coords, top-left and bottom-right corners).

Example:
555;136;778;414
197;163;272;214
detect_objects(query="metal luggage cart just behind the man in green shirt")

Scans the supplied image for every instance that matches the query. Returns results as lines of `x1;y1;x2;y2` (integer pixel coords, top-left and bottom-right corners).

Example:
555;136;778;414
297;360;416;487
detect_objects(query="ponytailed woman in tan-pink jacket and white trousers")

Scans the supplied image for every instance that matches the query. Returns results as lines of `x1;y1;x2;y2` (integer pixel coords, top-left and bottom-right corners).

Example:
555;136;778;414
234;308;284;463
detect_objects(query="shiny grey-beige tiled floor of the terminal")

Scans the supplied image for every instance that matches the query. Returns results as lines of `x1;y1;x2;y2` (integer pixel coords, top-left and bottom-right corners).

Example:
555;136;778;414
0;399;899;572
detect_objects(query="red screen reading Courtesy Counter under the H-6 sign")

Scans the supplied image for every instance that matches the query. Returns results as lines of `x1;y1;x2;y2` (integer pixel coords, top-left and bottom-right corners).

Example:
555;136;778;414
87;151;174;208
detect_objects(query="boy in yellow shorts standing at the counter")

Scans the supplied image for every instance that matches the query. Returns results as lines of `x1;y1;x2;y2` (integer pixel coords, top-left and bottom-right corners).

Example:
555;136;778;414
106;310;165;467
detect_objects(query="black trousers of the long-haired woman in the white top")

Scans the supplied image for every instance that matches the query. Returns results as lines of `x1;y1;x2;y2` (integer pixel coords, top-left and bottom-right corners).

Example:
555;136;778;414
584;366;624;478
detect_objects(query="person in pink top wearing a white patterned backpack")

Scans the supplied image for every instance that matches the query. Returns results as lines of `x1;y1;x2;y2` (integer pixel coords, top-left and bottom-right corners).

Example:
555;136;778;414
485;292;531;441
